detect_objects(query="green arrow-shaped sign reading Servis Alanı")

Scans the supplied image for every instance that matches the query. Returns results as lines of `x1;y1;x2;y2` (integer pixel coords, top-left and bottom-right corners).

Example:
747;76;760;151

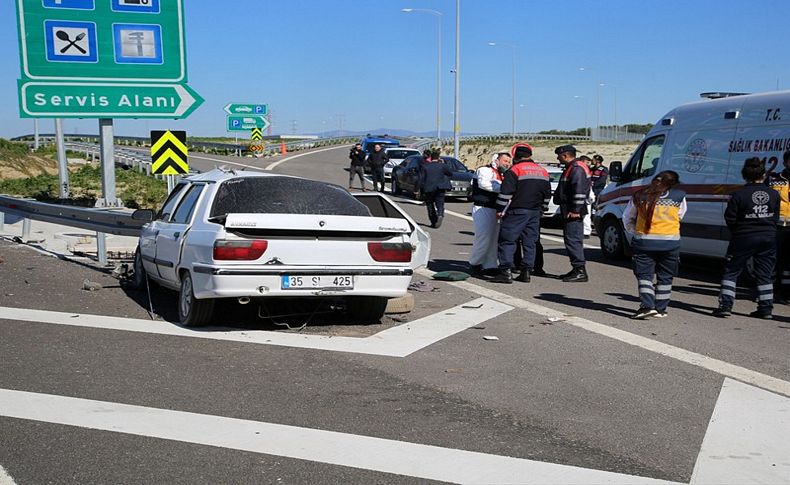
19;80;203;118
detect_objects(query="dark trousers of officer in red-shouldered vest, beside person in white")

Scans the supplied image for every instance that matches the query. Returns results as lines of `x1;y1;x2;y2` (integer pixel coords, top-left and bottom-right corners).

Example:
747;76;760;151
497;209;543;271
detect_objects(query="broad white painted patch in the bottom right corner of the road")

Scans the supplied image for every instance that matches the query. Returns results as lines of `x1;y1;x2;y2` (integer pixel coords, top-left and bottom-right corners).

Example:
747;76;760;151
691;379;790;485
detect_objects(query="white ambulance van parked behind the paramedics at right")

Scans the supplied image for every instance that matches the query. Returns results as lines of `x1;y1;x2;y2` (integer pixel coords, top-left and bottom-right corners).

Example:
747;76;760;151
595;91;790;258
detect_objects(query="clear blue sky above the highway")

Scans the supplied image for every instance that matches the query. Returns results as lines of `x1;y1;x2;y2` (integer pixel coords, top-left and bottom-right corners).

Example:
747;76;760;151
0;0;790;138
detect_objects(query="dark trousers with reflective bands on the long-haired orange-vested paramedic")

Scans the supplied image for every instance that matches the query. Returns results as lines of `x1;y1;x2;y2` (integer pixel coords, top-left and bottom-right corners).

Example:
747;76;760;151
633;248;680;312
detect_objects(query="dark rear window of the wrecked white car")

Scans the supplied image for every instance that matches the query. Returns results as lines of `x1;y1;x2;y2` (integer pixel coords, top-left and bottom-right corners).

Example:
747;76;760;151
209;176;370;218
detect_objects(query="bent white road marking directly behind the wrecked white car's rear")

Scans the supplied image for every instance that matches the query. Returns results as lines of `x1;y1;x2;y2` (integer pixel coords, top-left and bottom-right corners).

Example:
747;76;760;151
0;298;512;357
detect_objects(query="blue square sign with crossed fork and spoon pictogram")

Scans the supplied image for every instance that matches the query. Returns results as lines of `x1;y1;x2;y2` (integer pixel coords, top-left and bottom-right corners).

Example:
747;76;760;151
44;20;99;62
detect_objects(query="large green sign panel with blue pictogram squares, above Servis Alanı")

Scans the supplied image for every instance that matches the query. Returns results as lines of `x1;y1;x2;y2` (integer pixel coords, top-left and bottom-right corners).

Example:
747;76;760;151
16;0;187;83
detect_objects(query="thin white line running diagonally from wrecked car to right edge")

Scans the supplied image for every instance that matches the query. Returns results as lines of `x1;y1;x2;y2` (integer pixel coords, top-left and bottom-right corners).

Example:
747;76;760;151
415;268;790;396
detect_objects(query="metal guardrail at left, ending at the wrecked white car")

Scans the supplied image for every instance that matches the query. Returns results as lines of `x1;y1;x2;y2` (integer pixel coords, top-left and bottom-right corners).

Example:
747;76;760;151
0;195;146;236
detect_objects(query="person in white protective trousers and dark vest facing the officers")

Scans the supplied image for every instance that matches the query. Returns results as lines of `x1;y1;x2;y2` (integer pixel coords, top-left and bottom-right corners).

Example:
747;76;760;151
469;153;512;276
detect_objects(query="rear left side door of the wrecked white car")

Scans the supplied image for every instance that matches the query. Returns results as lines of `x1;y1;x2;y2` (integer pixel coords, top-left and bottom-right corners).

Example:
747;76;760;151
156;184;205;284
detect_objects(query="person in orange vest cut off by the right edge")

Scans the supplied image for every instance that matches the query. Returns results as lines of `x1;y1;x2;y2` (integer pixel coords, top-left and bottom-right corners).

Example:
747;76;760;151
766;150;790;304
